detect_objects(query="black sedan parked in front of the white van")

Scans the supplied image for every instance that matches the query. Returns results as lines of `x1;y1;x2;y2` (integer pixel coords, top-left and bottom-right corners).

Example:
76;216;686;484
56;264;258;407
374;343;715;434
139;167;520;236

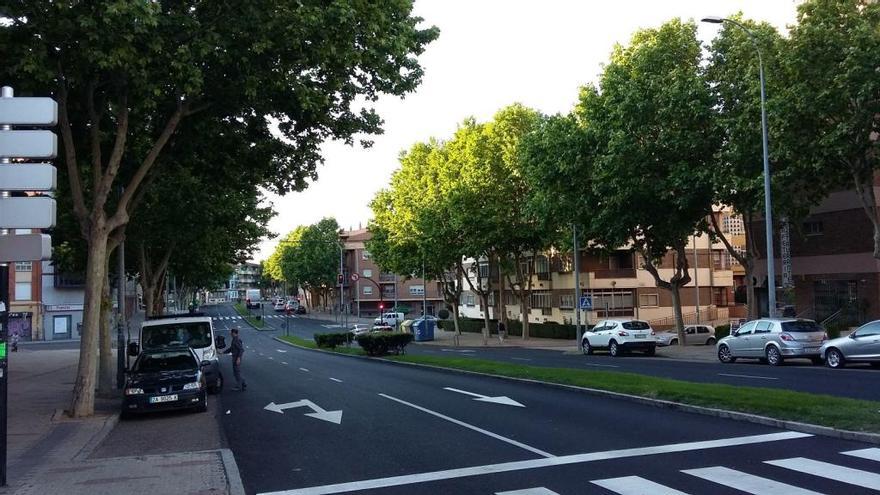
122;347;208;415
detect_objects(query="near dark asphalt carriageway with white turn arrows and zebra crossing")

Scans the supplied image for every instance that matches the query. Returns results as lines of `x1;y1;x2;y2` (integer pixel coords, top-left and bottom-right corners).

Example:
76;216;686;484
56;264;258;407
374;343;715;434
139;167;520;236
207;306;880;495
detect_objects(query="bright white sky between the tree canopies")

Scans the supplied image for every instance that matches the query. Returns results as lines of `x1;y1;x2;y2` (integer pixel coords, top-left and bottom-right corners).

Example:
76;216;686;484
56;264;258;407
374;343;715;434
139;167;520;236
254;0;799;260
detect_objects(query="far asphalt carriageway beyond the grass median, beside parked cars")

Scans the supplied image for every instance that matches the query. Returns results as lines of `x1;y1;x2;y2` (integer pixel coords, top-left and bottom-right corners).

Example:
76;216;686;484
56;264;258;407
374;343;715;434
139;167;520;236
215;308;880;400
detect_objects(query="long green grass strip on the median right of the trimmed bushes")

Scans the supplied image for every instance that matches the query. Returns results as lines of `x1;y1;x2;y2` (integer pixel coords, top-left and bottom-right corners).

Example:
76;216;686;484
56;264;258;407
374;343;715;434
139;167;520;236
388;355;880;433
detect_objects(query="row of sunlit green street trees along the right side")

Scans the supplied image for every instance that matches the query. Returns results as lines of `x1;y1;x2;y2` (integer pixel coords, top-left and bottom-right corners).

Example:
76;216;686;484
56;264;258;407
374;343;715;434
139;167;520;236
368;0;880;348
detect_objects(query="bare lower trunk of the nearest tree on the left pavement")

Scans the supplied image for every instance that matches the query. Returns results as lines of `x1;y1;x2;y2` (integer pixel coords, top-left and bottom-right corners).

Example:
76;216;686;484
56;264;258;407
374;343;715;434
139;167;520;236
69;229;109;418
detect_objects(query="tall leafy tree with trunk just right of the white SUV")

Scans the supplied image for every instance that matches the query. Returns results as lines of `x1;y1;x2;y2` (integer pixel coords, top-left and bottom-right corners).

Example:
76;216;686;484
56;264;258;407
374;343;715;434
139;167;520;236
578;20;718;342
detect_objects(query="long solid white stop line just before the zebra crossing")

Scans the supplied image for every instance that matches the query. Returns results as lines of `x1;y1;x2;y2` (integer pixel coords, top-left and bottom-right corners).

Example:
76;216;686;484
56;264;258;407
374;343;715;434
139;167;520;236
261;430;812;495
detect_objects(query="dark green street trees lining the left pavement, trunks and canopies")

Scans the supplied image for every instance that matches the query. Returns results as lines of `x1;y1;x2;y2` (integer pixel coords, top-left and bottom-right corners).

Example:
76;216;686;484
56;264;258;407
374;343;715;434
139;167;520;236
0;0;438;417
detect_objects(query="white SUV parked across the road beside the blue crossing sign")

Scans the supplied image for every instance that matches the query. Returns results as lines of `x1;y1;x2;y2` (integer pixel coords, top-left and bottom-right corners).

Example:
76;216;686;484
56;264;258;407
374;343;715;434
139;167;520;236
581;319;657;357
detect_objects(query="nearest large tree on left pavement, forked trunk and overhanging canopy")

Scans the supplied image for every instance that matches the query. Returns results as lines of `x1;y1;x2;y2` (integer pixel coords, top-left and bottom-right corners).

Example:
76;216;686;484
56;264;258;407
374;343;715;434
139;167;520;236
0;0;437;417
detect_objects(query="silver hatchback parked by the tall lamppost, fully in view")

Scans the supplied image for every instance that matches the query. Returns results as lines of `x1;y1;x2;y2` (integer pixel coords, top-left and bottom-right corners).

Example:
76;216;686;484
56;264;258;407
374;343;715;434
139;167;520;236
716;318;828;366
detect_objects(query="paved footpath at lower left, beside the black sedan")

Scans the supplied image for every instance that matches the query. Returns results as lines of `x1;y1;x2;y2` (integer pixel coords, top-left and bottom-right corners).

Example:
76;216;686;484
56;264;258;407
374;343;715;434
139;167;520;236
0;344;244;495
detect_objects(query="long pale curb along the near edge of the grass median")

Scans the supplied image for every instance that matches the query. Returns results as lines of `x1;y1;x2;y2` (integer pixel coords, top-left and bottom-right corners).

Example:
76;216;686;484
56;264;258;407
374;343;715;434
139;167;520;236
275;337;880;445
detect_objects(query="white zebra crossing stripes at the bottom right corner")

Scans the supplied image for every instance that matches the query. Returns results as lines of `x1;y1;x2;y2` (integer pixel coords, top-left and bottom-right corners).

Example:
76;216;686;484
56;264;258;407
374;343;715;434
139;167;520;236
495;448;880;495
